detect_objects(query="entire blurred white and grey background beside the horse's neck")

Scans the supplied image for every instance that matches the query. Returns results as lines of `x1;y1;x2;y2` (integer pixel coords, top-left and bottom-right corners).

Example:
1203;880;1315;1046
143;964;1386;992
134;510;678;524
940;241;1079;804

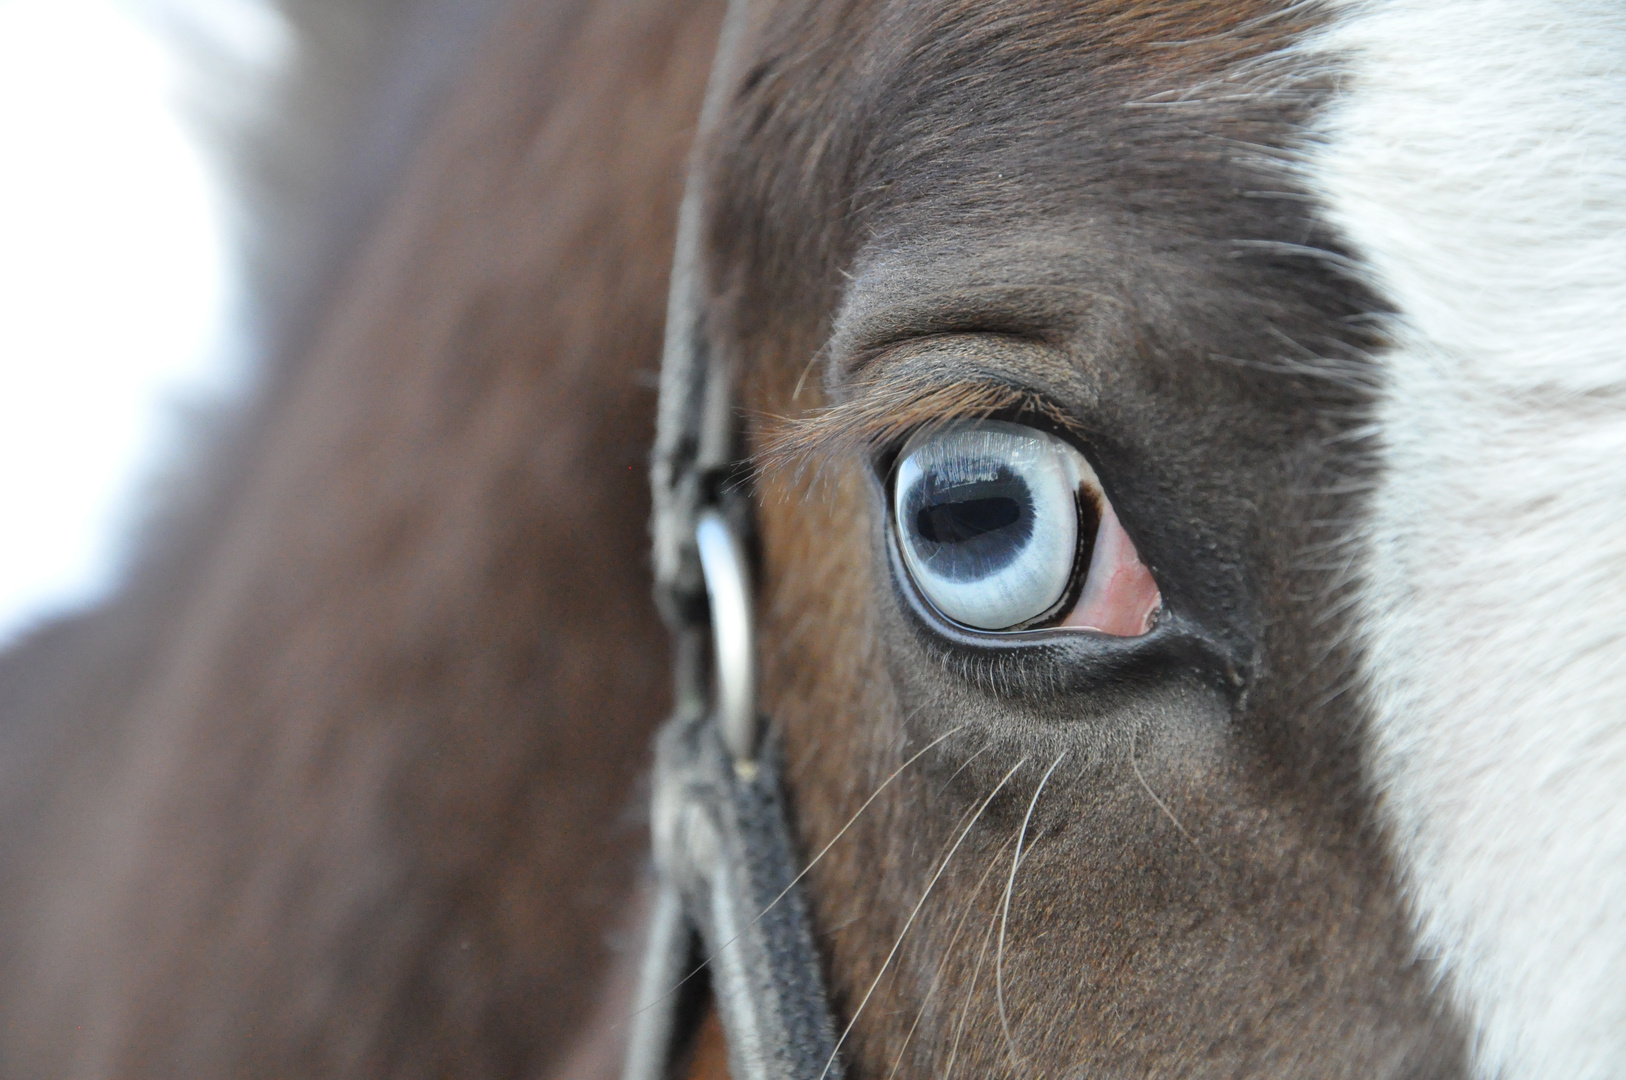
0;0;499;647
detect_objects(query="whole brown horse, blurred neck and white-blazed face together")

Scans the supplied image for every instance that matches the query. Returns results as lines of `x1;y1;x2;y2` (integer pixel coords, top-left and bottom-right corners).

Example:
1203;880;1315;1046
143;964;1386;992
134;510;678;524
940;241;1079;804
0;0;1626;1080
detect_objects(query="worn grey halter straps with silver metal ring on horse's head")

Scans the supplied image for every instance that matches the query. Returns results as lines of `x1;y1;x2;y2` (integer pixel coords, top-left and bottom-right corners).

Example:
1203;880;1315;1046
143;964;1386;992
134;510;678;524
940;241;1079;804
621;0;842;1080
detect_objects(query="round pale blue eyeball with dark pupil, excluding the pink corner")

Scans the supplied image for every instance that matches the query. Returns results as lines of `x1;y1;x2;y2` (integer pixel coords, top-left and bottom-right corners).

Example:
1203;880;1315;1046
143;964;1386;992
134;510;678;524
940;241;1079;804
893;420;1096;629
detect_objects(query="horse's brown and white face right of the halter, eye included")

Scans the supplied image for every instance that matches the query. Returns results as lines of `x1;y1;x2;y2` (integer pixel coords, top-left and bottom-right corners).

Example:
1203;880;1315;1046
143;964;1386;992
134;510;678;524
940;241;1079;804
653;2;1626;1077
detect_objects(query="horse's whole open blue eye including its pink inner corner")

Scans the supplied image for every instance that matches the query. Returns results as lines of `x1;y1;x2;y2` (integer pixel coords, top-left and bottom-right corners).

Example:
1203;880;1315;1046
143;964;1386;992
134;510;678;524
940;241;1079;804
893;420;1161;636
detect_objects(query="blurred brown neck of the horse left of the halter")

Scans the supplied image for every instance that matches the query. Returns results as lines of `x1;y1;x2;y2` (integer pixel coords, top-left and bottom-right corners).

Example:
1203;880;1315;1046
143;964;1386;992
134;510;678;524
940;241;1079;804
3;2;720;1077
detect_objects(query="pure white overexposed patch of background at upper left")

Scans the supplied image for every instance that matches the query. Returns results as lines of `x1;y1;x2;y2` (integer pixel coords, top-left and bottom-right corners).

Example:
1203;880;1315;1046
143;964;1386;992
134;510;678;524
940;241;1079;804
0;0;289;646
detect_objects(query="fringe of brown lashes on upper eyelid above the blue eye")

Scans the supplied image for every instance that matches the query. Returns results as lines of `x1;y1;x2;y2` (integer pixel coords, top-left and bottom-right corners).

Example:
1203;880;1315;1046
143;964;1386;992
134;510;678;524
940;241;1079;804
753;364;1078;477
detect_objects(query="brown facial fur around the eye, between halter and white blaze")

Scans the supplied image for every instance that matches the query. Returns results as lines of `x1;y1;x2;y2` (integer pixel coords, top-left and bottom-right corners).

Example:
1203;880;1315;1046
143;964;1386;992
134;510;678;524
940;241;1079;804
699;0;1463;1077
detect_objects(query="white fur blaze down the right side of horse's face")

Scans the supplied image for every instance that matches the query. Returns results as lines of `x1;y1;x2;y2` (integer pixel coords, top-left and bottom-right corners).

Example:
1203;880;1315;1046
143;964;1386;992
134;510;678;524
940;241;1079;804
1311;0;1626;1080
